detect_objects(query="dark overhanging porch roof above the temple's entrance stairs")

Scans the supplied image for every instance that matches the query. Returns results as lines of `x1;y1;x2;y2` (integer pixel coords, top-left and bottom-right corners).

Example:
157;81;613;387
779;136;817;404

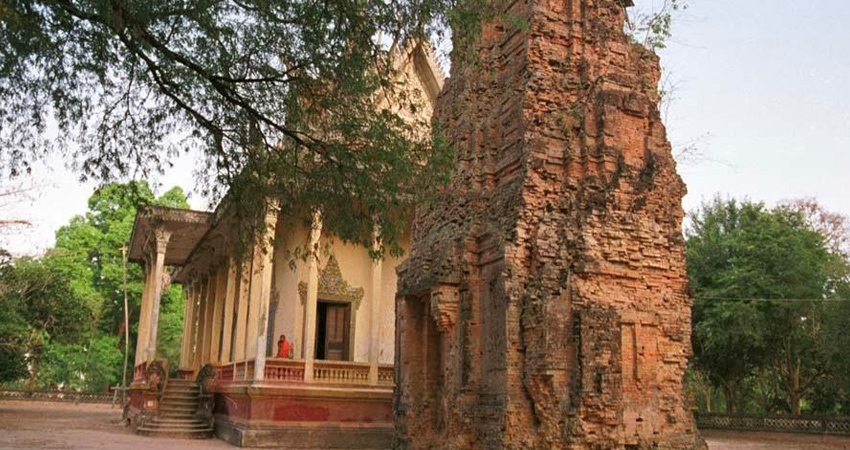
128;206;213;266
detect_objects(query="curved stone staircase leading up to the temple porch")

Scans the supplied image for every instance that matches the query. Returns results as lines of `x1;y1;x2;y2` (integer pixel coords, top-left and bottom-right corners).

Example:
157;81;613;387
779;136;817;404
136;379;213;439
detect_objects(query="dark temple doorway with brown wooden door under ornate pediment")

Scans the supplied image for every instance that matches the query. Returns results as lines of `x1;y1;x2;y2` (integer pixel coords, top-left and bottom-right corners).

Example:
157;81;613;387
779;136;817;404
315;300;351;361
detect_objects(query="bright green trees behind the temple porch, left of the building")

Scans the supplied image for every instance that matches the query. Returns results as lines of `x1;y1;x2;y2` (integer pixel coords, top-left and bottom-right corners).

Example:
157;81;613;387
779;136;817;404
0;182;188;391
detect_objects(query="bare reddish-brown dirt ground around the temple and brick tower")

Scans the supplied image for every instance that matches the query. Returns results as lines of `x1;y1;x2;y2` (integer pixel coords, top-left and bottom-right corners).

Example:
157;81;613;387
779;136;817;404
0;401;850;450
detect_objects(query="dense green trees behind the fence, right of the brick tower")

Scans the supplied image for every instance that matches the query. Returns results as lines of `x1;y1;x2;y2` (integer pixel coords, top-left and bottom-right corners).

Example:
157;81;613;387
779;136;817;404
685;198;850;415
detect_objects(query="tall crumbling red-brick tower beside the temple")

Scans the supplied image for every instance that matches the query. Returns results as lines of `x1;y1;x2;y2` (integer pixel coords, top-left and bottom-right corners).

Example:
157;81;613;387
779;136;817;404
394;0;697;449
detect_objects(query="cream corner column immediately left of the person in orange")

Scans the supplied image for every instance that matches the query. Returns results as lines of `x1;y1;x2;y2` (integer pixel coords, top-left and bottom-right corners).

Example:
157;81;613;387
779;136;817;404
254;206;278;381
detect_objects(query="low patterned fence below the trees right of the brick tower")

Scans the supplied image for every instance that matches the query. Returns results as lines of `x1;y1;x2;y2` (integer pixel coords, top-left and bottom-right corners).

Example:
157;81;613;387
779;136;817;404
695;413;850;436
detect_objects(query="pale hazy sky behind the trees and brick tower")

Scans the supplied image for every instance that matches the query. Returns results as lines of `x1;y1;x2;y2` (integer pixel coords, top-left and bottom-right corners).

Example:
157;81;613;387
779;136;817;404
0;0;850;255
